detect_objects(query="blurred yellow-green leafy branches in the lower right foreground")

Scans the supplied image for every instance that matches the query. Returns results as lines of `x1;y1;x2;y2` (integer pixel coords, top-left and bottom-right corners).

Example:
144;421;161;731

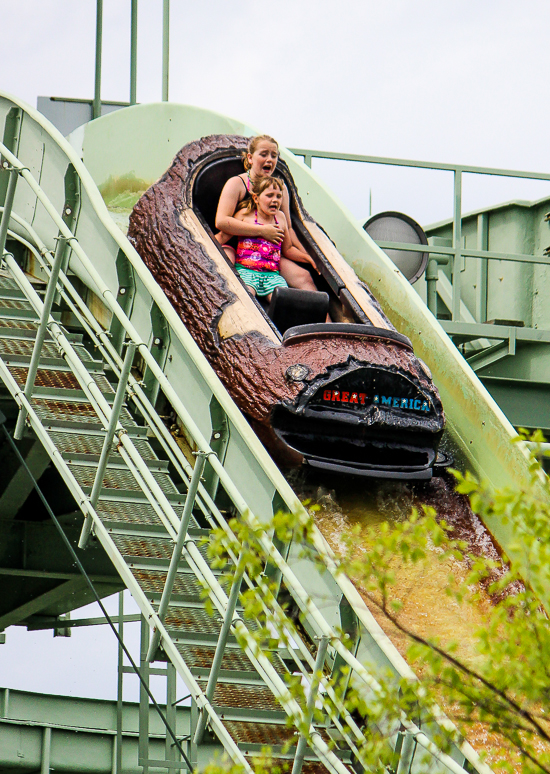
199;434;550;774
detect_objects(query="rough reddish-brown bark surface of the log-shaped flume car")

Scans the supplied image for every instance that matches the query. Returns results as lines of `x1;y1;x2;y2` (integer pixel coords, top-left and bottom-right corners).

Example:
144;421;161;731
128;135;444;462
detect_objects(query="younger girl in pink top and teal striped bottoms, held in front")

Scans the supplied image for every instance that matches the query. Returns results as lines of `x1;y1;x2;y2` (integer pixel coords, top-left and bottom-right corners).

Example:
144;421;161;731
217;177;309;301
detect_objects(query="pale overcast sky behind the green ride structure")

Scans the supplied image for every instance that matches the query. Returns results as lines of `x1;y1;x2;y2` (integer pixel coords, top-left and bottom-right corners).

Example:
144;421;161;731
0;0;550;697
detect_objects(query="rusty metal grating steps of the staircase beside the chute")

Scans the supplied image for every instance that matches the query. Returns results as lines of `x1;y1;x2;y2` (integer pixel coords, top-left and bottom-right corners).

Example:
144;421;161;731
0;276;349;771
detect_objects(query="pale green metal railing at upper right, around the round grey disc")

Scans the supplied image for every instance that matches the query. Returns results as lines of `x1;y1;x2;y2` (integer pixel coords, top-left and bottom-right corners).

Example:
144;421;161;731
290;148;550;322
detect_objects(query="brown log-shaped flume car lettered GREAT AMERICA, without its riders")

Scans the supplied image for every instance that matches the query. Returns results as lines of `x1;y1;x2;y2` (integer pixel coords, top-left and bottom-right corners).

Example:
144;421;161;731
128;135;445;479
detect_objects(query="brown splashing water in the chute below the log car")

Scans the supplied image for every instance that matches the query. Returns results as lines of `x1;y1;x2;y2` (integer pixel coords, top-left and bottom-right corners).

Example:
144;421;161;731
294;476;520;772
